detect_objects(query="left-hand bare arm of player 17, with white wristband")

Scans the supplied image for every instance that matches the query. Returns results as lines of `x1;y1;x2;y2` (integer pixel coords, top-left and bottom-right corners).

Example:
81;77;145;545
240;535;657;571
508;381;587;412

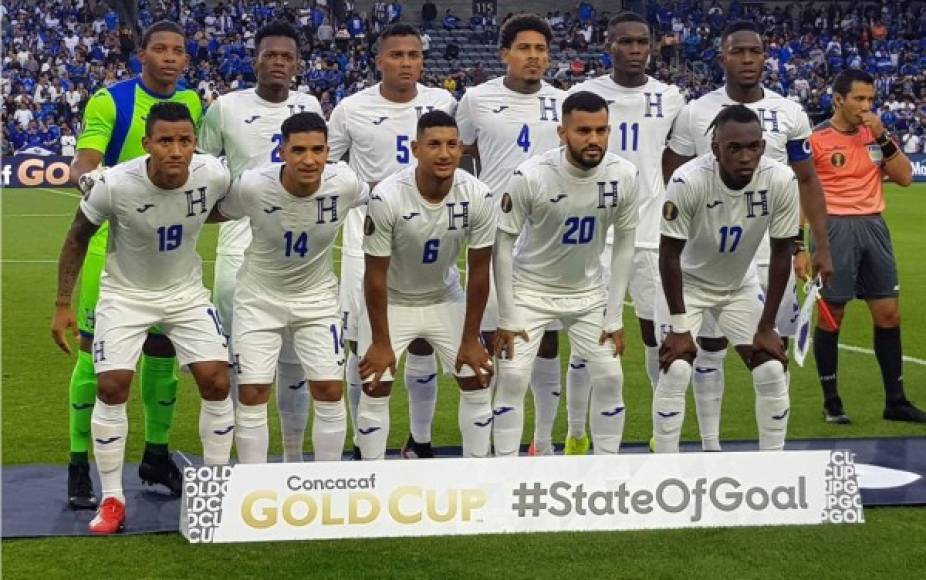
659;236;698;371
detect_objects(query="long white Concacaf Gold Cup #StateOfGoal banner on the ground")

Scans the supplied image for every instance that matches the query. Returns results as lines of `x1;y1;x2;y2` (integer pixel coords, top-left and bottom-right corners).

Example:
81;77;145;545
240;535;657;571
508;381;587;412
180;451;864;543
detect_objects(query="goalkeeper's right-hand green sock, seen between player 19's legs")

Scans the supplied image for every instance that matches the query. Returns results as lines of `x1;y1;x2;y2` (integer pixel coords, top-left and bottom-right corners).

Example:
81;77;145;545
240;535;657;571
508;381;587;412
141;355;179;452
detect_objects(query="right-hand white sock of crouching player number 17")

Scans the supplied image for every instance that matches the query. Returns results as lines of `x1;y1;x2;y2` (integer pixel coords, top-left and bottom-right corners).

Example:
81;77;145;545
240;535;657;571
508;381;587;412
752;360;790;451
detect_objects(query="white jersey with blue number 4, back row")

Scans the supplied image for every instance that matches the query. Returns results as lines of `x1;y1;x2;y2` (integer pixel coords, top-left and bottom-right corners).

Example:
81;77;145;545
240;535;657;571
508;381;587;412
457;77;566;195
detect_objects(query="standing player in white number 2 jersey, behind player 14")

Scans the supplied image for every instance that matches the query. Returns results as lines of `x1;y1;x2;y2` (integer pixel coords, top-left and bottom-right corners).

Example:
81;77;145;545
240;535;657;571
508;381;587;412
199;22;322;462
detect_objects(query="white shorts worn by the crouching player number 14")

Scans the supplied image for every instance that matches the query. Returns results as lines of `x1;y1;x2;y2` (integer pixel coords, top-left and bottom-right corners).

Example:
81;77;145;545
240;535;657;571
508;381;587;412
233;285;345;385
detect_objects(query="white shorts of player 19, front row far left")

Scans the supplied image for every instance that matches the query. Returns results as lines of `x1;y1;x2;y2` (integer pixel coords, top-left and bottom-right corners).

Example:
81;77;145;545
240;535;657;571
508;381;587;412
92;287;228;374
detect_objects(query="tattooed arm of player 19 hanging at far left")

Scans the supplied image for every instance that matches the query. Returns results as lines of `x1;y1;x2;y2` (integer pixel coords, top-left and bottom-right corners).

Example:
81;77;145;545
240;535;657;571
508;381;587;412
51;208;100;354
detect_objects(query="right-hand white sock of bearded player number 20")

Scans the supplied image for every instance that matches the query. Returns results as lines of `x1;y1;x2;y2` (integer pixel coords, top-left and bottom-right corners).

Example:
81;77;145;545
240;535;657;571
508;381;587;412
586;359;627;455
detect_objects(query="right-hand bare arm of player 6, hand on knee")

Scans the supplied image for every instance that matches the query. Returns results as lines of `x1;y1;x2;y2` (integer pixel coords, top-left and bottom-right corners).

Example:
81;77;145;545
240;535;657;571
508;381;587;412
455;246;492;386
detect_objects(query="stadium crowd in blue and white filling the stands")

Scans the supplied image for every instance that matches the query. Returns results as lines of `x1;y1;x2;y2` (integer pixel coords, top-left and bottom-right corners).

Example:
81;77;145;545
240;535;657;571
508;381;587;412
0;0;926;155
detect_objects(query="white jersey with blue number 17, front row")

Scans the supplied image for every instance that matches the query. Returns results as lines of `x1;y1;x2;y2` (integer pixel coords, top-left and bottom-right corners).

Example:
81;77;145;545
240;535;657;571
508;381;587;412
661;154;799;292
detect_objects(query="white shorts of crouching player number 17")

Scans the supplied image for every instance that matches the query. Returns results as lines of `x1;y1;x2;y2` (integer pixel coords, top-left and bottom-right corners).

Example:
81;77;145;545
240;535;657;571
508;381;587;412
656;276;764;346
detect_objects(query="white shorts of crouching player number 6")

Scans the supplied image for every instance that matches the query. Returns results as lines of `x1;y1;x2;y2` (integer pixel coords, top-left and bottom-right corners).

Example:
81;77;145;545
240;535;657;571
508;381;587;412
359;302;476;381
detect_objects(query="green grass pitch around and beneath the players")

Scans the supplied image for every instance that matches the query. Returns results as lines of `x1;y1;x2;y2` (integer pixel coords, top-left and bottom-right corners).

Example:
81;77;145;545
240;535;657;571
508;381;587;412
2;185;926;578
